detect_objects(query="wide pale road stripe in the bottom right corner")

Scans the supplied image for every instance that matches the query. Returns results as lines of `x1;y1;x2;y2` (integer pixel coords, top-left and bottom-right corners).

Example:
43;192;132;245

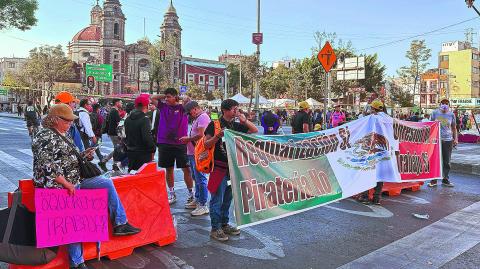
339;202;480;269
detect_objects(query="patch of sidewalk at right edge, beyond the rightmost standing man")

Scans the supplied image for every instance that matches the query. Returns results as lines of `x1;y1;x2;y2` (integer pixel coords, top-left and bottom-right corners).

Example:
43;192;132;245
450;143;480;175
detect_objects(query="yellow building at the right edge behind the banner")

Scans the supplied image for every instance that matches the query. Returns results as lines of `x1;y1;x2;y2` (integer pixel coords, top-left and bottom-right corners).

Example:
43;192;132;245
438;41;480;100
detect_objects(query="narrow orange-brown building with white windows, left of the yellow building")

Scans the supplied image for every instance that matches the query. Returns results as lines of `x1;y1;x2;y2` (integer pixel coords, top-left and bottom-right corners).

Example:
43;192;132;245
419;69;440;108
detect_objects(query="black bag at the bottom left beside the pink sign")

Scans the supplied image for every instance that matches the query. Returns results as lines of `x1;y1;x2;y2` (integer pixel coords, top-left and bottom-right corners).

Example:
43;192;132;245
0;190;58;265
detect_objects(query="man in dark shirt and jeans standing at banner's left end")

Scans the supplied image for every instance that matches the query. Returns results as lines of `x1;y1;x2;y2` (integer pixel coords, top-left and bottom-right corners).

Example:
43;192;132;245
205;99;258;241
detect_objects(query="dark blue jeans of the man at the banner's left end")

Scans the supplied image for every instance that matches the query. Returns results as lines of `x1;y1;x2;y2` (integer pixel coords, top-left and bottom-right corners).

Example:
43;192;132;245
210;176;233;230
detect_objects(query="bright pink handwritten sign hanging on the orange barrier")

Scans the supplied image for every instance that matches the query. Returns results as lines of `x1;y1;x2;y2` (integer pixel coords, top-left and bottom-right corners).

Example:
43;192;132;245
35;188;108;248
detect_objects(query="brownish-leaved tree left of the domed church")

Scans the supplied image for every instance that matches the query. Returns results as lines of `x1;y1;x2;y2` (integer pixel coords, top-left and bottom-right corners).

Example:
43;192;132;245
21;45;75;103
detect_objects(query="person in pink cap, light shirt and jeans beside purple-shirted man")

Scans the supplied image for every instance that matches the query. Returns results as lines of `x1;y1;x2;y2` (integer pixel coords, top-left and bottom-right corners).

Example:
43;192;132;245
180;101;210;216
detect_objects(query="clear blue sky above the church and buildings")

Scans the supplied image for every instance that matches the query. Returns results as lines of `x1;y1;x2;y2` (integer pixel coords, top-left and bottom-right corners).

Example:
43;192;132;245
0;0;480;75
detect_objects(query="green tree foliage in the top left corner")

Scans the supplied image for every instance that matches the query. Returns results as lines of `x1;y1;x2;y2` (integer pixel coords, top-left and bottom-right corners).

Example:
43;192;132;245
0;0;38;31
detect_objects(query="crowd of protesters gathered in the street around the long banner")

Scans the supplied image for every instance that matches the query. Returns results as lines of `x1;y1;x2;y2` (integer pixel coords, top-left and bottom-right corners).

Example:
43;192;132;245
25;88;464;268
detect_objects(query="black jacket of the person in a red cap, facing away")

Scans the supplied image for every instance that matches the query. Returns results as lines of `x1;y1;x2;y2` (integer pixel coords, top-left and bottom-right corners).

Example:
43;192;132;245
125;110;156;153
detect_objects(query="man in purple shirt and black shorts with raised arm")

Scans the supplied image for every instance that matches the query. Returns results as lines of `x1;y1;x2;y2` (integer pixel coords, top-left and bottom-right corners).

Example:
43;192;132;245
152;88;194;205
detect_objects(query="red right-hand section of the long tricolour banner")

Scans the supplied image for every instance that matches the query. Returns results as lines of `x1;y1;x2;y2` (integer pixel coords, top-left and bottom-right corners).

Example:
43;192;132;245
394;120;442;181
